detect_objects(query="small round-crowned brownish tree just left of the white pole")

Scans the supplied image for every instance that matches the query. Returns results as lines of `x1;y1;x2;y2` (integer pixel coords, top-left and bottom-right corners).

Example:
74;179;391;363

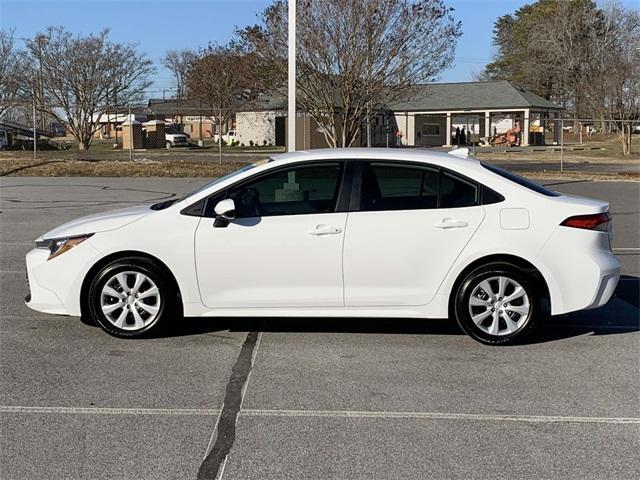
186;43;258;151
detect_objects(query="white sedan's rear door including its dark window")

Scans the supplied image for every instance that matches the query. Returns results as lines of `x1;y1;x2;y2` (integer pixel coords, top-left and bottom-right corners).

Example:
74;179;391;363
343;162;484;307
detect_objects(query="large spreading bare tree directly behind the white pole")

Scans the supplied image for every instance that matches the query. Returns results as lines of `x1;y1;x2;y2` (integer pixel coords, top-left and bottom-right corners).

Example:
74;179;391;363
238;0;461;147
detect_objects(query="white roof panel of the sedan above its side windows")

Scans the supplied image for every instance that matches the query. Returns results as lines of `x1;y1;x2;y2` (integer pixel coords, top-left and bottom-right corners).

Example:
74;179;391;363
272;147;479;167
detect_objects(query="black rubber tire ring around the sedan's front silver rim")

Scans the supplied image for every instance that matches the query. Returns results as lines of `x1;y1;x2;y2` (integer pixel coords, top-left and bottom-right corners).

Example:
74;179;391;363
88;258;173;338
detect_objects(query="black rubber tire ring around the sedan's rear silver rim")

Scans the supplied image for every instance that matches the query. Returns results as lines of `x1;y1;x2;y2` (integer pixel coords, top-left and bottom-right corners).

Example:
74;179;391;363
454;264;541;345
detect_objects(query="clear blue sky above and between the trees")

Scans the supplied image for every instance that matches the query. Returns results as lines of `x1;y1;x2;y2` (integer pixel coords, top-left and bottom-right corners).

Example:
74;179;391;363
0;0;640;98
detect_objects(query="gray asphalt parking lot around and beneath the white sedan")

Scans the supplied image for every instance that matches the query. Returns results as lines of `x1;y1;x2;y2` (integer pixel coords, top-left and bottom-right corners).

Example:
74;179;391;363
0;178;640;479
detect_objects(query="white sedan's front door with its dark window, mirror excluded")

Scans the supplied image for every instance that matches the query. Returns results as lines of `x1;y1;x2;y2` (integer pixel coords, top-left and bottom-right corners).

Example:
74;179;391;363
195;162;347;308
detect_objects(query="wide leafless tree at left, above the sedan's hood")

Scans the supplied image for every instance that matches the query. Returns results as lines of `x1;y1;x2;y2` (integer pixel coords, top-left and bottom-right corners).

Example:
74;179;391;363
26;27;154;150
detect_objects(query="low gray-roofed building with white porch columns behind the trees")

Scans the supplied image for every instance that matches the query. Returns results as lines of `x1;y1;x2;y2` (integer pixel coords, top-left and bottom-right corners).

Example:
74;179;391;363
236;81;561;149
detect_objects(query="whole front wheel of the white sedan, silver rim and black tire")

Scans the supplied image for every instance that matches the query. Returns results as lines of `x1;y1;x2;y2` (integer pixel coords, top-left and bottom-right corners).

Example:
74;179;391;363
88;257;177;338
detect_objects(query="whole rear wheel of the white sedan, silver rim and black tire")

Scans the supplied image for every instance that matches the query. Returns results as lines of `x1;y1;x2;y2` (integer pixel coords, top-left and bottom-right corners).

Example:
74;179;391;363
454;263;542;345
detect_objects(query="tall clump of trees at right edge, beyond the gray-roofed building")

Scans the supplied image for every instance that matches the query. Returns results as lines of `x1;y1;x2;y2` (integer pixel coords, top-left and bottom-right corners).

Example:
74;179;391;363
481;0;640;147
